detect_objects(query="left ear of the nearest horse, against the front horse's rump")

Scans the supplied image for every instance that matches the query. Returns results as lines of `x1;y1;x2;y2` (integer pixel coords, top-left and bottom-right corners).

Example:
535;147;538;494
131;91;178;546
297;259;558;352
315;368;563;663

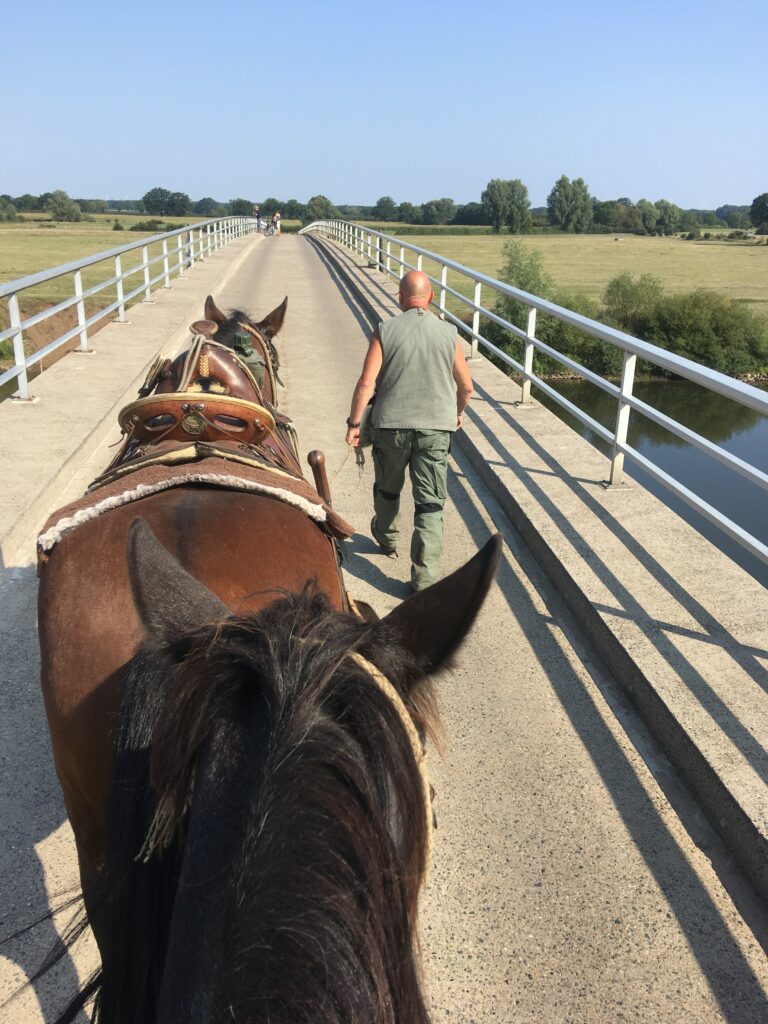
128;519;231;642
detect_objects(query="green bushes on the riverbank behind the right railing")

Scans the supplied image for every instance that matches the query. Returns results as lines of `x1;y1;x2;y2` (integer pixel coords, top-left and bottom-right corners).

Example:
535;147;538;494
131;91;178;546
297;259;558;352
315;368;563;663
484;240;768;378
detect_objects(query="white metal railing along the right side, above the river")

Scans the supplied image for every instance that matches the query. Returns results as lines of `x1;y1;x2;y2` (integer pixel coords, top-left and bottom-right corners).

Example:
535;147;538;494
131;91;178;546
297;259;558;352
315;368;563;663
300;220;768;564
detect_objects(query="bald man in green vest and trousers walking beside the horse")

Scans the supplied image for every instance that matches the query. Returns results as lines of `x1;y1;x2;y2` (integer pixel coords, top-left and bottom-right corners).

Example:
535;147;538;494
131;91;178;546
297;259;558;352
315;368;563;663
346;270;472;591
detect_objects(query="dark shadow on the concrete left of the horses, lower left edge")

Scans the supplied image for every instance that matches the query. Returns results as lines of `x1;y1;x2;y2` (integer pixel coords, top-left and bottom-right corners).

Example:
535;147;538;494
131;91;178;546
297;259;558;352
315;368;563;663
0;566;86;1022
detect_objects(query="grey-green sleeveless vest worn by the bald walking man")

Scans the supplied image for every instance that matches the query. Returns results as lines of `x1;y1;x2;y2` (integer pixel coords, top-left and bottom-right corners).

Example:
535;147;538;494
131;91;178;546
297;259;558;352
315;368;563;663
373;309;457;430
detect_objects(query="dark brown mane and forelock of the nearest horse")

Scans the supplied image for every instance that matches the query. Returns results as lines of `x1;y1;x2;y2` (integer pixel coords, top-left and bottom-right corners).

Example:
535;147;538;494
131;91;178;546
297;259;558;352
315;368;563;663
130;589;438;1024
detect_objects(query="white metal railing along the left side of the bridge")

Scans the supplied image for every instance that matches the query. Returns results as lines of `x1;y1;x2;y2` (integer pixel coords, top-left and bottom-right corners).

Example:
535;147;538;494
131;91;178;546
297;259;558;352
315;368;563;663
0;217;256;399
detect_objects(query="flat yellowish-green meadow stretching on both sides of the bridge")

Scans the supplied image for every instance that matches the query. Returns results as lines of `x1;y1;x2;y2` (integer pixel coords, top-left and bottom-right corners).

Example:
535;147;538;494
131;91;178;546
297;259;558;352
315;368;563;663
0;213;768;378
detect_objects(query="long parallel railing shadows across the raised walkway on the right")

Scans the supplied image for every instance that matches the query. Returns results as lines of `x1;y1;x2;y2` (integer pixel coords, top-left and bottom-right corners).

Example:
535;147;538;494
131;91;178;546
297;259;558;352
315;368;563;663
469;385;768;782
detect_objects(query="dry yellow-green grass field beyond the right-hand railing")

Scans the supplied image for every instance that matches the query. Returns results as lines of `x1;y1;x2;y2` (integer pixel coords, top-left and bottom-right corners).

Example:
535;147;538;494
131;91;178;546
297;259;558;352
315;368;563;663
370;231;768;315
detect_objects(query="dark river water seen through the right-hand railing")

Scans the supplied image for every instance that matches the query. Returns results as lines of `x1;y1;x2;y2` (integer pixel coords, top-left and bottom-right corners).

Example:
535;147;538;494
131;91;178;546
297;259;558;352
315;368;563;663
534;381;768;587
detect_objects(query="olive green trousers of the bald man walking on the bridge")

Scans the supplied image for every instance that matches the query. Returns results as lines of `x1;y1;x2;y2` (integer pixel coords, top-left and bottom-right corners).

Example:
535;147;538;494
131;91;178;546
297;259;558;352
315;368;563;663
373;429;451;590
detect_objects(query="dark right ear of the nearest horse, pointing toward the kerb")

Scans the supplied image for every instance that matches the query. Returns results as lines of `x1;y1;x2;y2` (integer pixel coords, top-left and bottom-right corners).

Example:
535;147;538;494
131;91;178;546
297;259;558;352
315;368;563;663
374;534;502;673
